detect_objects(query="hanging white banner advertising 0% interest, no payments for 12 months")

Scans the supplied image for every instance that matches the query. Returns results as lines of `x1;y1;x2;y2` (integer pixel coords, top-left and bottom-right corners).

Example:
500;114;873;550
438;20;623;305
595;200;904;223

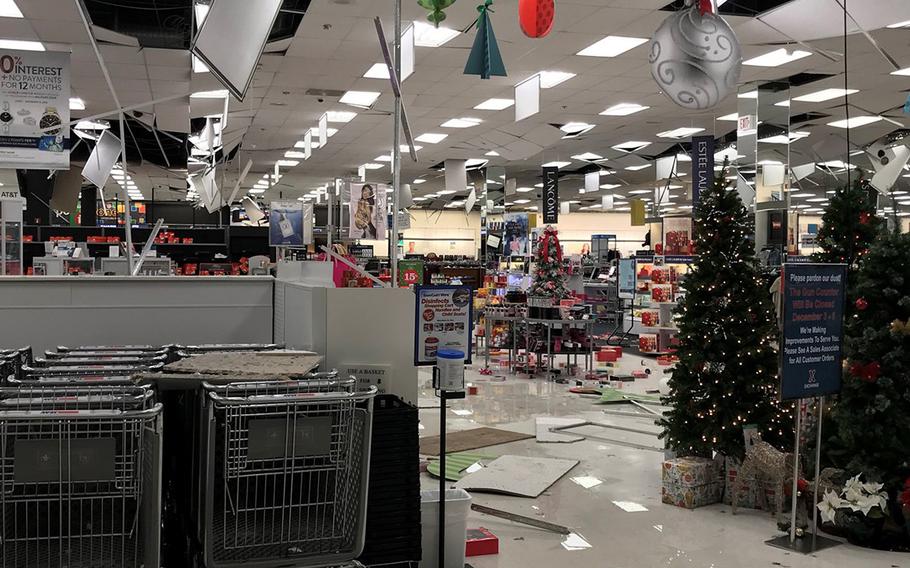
0;49;70;169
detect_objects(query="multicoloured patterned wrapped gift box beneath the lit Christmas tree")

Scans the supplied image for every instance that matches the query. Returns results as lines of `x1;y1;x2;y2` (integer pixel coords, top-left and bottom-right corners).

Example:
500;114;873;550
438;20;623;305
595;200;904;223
661;458;724;509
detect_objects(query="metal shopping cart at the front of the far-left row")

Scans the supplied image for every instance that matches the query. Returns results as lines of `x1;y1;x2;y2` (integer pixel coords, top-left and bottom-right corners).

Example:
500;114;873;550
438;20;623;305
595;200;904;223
0;387;162;568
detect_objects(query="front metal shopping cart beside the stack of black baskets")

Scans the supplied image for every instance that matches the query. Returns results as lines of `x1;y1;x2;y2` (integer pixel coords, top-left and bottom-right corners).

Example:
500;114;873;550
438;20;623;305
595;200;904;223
197;379;376;568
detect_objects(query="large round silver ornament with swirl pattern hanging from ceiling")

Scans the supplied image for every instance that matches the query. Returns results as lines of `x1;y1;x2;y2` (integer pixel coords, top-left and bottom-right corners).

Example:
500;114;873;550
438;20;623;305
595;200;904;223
649;0;742;110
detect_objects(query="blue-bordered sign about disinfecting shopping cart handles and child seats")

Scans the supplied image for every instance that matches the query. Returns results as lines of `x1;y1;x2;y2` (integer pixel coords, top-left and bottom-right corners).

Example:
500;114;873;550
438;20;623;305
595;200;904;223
414;286;474;365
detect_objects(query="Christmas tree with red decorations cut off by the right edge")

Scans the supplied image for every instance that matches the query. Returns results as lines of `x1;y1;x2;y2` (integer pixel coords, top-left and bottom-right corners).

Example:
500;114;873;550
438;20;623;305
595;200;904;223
829;233;910;496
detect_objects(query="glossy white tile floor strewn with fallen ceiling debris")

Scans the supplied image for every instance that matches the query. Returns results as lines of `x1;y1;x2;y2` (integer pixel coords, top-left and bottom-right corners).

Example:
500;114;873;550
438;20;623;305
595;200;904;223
420;355;910;568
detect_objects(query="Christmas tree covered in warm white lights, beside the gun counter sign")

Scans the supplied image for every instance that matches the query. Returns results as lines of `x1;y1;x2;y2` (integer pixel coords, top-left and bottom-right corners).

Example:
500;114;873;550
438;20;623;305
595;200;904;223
660;167;793;458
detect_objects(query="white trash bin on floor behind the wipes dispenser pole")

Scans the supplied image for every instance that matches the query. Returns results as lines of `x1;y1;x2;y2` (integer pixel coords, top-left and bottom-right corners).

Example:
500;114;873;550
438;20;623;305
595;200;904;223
420;489;471;568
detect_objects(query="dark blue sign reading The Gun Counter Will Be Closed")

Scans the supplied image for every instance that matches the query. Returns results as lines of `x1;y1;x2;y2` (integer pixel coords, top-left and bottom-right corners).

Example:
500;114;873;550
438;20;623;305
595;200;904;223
780;263;847;400
